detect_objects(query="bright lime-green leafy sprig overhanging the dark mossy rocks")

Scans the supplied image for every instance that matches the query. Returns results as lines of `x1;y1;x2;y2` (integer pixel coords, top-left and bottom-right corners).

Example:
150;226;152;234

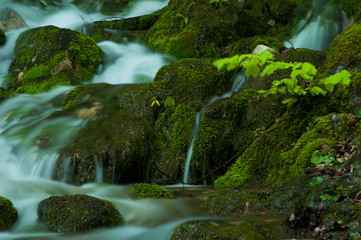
213;51;351;106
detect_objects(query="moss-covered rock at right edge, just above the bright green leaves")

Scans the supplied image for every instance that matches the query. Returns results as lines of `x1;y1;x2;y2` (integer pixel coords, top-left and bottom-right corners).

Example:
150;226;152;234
316;22;361;78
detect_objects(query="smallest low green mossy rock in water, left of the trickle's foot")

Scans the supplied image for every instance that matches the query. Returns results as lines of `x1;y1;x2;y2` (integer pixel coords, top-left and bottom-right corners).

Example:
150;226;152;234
130;183;173;199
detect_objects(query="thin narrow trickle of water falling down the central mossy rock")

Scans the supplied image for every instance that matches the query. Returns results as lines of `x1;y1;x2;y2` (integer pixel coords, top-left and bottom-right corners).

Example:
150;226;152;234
183;73;246;183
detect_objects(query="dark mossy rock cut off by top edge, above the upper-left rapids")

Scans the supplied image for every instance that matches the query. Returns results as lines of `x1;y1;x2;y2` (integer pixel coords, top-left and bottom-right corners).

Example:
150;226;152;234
72;0;134;15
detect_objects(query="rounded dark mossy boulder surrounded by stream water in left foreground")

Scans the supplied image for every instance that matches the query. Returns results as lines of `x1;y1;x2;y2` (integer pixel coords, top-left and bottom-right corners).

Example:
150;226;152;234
38;194;124;233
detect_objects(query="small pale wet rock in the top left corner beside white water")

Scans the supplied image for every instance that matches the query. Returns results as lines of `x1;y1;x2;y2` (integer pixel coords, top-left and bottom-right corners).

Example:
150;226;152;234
0;8;27;32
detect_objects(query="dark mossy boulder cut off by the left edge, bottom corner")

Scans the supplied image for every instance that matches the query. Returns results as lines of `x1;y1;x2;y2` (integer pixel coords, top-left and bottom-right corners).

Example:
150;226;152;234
0;197;18;231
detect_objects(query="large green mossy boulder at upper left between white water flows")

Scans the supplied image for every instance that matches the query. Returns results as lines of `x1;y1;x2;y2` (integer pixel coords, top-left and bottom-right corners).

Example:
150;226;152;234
7;26;103;94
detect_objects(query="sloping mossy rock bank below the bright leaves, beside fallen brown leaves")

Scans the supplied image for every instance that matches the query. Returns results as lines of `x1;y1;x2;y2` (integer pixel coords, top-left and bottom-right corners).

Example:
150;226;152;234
215;111;355;187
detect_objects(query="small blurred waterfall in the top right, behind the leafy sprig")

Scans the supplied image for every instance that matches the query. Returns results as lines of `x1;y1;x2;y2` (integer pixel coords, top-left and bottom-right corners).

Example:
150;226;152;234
284;0;346;50
